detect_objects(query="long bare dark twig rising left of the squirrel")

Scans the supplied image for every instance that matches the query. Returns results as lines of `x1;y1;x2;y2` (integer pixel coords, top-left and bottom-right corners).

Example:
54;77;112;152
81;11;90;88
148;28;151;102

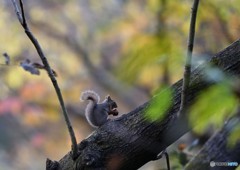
12;0;78;159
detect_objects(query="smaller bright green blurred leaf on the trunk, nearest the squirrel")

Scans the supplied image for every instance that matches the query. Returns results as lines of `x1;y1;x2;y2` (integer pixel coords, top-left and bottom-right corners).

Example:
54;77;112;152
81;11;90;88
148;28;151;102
145;88;172;122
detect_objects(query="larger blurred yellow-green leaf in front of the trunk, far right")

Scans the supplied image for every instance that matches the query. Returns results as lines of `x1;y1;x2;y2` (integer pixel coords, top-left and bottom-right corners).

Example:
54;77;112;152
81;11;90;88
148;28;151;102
189;83;237;133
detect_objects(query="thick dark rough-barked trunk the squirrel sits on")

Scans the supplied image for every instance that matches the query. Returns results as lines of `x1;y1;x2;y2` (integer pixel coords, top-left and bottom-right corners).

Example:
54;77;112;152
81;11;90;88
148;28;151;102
47;40;240;170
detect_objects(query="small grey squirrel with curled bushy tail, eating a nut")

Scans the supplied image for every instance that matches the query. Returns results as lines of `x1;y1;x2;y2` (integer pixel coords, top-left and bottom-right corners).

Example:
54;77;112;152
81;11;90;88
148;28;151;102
80;90;118;127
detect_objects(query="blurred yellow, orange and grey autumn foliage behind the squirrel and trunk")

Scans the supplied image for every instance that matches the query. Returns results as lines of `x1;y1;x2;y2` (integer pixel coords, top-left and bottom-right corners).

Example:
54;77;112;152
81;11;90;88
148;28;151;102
0;0;240;170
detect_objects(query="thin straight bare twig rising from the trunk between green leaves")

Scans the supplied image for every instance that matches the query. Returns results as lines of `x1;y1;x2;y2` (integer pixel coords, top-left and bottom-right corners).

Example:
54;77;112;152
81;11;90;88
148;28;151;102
178;0;199;116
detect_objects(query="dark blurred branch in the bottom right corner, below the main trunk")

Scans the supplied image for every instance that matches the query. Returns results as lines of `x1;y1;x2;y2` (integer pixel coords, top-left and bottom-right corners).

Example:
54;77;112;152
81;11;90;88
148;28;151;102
185;114;240;170
